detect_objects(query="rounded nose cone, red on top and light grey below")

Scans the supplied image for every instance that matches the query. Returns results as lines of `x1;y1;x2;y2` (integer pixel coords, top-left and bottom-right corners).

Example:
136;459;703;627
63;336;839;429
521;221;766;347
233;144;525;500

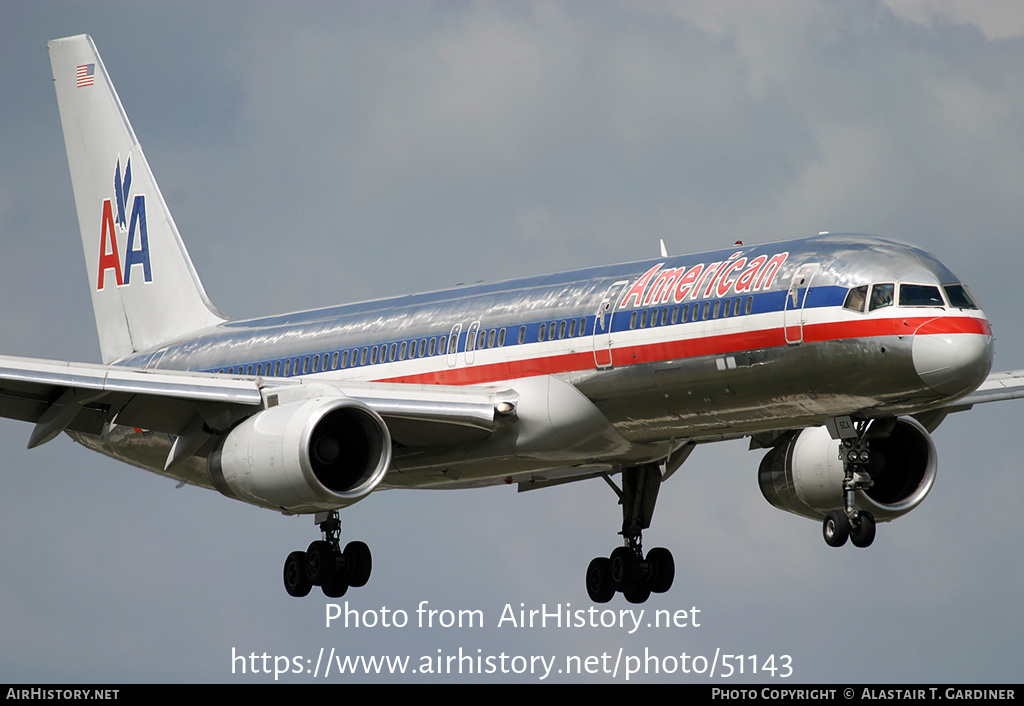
912;319;992;394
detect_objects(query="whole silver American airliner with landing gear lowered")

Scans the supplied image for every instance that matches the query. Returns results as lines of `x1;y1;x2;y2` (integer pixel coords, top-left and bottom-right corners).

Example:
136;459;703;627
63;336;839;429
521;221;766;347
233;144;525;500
0;35;1024;604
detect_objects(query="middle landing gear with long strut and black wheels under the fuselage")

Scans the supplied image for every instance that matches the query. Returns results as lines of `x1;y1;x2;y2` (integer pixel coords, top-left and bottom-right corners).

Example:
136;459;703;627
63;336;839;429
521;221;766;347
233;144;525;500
587;463;676;604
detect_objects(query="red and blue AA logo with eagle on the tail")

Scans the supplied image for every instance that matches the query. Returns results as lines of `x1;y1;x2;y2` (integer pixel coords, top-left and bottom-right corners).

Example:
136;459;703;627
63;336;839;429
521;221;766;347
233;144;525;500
96;156;153;291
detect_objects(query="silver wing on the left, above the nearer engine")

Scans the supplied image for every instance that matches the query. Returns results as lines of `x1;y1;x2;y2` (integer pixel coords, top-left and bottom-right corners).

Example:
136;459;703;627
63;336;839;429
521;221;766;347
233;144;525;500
0;356;515;448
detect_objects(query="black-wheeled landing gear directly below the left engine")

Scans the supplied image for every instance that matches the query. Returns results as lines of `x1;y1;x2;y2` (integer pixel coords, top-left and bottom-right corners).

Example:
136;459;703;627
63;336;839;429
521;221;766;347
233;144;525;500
285;510;373;598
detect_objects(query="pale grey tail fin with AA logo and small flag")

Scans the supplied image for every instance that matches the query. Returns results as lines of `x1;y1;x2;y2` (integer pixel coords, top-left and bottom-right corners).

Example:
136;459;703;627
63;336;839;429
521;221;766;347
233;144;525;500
48;35;225;363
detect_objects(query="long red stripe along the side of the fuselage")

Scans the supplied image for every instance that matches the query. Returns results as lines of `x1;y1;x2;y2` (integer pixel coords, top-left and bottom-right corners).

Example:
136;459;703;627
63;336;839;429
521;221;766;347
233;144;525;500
378;317;992;385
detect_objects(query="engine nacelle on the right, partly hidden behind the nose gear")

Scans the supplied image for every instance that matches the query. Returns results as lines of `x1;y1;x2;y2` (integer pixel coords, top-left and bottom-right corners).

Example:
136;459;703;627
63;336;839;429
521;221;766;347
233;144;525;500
758;418;938;522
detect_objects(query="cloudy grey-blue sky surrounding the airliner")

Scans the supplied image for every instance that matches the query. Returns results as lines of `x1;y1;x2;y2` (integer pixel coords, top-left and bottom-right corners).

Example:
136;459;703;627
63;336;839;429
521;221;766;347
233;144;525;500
0;0;1024;687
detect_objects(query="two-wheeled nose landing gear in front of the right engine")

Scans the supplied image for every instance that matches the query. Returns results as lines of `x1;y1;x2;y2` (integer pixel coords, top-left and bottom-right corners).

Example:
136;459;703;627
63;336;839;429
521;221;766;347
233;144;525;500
821;419;880;547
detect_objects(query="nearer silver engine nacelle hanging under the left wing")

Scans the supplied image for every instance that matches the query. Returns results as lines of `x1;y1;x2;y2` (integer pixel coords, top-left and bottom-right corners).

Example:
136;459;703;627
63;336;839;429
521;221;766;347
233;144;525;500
208;398;391;512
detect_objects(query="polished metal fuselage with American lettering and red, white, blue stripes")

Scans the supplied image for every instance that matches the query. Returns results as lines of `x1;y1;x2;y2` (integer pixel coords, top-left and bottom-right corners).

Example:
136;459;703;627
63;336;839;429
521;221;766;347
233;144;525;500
75;236;992;487
